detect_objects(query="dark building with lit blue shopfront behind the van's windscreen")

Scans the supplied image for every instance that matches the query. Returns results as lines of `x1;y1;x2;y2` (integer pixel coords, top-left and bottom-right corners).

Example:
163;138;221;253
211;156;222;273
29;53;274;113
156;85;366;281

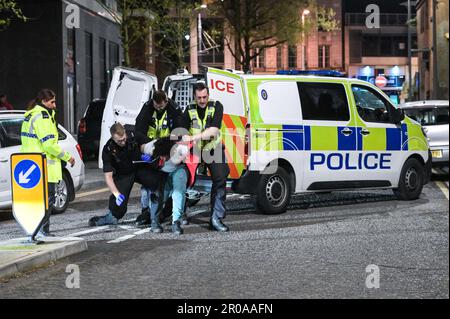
343;0;418;103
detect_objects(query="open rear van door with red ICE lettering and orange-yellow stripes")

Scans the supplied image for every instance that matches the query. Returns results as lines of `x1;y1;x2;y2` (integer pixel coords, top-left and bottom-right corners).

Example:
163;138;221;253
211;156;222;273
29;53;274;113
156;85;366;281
206;68;248;179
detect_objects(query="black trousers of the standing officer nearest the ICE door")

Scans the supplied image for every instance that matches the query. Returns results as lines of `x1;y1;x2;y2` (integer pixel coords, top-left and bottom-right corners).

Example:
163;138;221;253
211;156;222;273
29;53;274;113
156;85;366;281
206;146;230;219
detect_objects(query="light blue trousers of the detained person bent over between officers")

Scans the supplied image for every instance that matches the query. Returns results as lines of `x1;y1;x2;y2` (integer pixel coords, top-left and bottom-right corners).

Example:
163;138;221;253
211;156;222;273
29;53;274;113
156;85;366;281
164;165;188;222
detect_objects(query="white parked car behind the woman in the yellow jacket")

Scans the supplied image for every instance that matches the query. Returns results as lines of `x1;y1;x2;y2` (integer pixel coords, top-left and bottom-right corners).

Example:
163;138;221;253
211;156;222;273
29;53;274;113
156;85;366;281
0;111;84;214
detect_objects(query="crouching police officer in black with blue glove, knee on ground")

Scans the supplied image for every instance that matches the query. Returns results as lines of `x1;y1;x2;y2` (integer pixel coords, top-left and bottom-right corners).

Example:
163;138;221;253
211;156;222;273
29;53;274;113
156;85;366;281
89;123;164;226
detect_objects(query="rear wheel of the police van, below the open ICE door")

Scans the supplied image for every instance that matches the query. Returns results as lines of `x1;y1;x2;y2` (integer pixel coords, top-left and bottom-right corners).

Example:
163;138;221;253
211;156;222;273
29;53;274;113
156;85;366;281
254;167;291;214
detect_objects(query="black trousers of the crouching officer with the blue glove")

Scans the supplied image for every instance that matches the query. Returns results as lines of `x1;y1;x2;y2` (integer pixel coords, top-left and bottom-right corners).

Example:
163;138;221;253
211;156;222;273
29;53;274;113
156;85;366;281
109;168;166;219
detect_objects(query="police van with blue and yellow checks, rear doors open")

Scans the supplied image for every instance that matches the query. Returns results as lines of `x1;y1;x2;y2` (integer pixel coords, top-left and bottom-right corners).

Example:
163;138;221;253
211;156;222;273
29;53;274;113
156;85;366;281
100;68;431;214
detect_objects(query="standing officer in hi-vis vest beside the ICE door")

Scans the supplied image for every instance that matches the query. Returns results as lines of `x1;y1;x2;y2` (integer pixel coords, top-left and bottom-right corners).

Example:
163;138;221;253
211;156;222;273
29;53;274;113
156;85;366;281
183;82;230;232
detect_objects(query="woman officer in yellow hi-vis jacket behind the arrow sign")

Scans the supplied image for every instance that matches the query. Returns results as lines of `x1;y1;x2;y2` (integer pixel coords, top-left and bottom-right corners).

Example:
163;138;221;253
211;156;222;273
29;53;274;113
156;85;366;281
21;89;75;236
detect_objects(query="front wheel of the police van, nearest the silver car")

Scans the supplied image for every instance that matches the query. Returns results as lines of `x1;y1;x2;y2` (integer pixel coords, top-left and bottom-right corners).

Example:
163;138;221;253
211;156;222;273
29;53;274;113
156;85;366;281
393;158;425;200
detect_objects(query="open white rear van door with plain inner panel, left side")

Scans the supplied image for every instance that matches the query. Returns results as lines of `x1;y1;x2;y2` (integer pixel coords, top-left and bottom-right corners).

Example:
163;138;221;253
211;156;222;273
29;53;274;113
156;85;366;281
98;67;158;168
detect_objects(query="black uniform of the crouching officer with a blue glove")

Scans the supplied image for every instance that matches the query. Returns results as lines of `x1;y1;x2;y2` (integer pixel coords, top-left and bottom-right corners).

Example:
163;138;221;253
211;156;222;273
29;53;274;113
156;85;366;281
102;130;166;219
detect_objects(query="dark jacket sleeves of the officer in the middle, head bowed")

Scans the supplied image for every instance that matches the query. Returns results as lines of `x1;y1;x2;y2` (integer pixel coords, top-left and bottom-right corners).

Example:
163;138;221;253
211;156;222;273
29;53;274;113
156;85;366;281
135;99;182;145
